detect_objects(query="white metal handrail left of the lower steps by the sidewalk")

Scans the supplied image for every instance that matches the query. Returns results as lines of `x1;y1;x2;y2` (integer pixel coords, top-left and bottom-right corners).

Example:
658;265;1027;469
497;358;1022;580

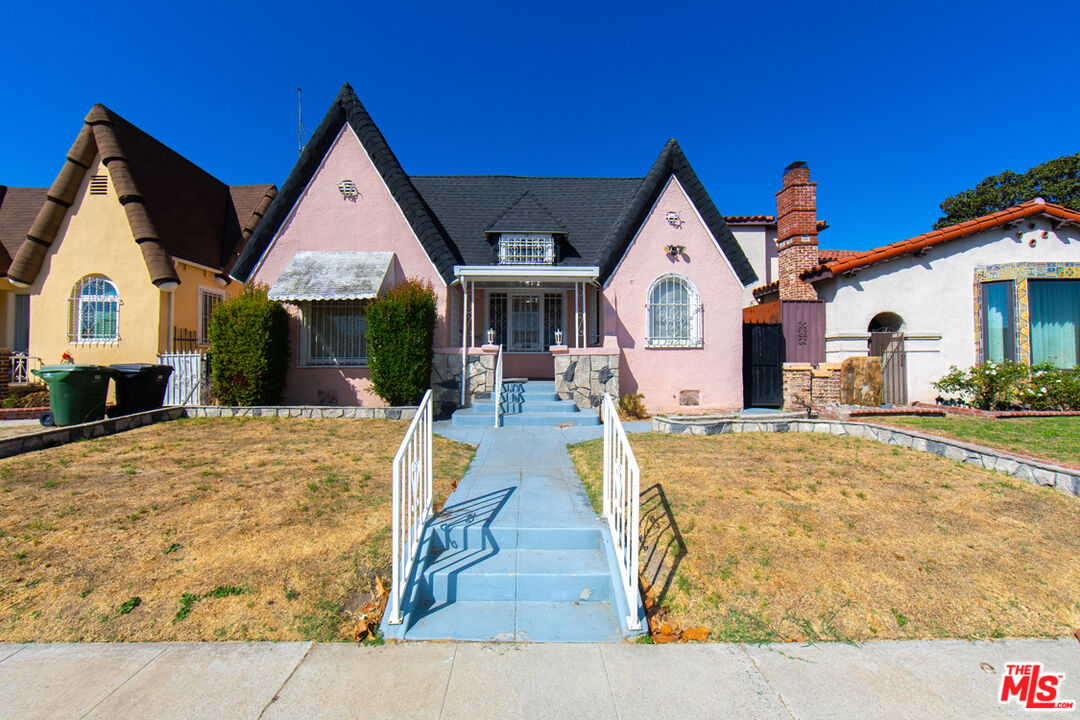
390;390;432;625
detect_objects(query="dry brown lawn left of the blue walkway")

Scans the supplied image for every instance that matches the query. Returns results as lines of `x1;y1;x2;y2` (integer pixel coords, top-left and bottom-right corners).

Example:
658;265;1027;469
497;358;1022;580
0;419;473;642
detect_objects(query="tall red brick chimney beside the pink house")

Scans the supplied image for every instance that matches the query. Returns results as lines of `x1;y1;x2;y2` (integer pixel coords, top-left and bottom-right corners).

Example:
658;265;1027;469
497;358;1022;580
777;162;818;300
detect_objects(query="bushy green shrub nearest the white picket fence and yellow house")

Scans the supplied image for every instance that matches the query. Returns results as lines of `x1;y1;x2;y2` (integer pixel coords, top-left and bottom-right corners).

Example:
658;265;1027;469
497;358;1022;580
210;284;289;405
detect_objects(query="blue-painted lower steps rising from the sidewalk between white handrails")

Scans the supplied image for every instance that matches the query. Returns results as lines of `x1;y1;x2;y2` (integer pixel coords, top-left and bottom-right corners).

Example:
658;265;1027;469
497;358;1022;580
393;516;623;642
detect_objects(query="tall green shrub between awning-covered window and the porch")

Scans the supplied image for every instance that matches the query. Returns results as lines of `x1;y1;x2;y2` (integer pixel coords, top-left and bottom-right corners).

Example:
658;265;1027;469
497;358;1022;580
367;280;435;405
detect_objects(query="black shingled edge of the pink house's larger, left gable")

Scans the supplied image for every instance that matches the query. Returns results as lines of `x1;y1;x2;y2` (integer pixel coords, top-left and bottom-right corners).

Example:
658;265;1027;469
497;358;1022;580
231;83;461;283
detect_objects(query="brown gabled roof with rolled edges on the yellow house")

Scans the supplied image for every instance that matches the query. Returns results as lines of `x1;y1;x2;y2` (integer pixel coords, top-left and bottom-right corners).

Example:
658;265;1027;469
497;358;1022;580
8;105;273;285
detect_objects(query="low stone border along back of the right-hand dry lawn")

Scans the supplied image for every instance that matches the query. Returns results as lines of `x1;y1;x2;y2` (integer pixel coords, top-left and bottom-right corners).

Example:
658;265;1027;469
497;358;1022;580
652;418;1080;497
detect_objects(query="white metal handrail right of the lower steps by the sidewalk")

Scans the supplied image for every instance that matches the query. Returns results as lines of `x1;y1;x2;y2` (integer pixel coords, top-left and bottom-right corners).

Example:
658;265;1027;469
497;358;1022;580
600;393;642;630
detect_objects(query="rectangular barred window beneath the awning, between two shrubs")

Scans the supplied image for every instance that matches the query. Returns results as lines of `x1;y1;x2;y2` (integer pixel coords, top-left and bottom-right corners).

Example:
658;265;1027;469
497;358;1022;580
300;300;367;367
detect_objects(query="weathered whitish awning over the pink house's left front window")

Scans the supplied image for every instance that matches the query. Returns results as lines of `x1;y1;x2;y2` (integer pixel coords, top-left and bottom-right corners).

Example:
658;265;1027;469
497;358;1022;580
269;250;394;300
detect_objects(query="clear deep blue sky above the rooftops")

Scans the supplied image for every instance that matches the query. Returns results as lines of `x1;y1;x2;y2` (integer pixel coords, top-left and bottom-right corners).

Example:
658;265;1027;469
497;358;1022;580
0;0;1080;249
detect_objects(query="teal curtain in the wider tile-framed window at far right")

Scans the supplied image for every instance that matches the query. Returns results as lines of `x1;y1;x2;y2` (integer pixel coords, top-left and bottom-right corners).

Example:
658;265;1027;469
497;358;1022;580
1028;280;1080;367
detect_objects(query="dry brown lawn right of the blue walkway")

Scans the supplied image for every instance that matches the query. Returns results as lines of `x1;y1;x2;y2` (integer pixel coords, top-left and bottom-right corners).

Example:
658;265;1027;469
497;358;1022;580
571;433;1080;642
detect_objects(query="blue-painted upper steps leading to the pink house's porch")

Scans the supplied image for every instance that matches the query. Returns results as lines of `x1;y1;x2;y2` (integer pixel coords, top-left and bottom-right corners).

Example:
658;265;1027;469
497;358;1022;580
450;378;600;427
